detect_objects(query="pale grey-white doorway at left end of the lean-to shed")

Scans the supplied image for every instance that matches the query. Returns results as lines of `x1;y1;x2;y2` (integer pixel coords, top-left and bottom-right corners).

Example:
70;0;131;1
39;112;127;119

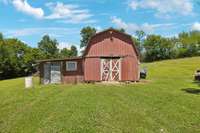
44;62;61;84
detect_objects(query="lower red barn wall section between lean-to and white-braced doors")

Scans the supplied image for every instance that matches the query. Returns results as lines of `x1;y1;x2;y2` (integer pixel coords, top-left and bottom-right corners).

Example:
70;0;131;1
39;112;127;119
84;58;101;81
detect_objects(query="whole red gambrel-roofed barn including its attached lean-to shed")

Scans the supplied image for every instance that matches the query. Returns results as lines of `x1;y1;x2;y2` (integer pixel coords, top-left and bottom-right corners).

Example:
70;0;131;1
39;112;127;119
40;29;139;84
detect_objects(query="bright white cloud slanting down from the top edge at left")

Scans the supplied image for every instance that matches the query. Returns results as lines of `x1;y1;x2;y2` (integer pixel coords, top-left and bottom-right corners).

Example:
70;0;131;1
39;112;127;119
12;0;44;18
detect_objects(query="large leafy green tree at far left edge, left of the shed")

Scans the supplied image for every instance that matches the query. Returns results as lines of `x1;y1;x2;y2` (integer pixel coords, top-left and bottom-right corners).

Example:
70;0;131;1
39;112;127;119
0;39;36;79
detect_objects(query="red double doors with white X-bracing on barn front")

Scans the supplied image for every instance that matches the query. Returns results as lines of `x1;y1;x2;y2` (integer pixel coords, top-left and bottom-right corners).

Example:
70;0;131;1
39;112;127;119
101;58;121;81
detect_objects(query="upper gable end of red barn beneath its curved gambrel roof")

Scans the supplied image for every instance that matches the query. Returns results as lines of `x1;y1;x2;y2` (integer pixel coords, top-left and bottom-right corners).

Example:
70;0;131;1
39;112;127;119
84;28;139;58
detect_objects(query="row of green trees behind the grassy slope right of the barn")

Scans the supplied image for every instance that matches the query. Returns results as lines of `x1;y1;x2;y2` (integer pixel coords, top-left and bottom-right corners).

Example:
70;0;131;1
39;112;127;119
133;31;200;62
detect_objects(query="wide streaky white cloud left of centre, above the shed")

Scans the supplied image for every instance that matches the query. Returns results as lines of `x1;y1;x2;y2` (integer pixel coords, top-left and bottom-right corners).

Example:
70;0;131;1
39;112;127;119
45;2;94;23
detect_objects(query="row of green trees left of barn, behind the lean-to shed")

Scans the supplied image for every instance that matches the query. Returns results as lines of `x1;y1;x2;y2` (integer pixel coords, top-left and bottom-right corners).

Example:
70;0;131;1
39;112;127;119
0;33;78;79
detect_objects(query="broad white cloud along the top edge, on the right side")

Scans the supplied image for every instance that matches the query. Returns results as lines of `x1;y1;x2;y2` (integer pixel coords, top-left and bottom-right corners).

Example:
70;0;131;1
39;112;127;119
129;0;193;17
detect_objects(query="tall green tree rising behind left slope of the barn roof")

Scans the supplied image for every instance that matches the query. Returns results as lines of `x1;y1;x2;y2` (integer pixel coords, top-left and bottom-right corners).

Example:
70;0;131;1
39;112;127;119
80;26;97;48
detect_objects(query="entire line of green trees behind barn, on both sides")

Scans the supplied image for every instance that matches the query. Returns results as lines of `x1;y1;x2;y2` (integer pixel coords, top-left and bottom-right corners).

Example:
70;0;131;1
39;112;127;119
0;26;200;79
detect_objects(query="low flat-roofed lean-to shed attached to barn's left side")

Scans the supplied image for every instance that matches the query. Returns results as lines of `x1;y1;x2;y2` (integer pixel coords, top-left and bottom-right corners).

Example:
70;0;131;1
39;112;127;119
39;57;84;84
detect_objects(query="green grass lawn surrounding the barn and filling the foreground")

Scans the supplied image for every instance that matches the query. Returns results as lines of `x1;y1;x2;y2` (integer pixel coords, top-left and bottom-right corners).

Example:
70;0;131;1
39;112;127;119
0;57;200;133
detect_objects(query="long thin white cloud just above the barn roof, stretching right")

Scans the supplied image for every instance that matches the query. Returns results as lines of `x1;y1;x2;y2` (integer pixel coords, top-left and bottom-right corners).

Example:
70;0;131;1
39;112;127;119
111;17;175;33
